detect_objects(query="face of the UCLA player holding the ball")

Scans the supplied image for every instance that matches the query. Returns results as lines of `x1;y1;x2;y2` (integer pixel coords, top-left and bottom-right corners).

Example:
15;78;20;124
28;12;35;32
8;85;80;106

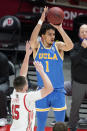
42;29;55;45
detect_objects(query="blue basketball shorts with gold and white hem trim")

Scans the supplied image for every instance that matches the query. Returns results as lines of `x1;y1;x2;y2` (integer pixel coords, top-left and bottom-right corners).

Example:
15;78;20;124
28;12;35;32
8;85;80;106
36;89;66;111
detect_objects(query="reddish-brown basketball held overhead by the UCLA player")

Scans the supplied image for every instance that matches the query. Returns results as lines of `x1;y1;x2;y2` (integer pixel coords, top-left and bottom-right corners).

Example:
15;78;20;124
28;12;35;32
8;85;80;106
46;7;64;25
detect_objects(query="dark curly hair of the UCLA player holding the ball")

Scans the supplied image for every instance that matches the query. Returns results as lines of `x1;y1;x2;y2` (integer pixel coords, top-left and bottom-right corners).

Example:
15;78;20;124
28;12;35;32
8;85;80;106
39;23;55;36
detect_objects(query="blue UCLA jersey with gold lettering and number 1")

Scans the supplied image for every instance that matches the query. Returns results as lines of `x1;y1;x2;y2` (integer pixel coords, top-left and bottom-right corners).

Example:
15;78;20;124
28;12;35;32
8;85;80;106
35;42;64;89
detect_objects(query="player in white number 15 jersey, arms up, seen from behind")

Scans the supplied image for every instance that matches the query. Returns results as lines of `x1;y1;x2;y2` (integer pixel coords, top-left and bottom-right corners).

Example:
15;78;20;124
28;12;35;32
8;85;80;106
10;41;53;131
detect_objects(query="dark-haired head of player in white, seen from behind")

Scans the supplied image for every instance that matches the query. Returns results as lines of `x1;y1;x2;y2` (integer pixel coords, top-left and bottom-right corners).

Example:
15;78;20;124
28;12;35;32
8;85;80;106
13;76;27;91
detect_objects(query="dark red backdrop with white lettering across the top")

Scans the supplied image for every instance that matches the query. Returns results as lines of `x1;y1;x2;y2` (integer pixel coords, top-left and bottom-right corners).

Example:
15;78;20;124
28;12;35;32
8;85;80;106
0;0;87;30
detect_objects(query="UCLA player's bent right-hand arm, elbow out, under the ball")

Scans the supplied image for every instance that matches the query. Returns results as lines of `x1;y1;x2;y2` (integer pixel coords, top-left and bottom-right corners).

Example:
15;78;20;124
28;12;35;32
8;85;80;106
52;24;73;51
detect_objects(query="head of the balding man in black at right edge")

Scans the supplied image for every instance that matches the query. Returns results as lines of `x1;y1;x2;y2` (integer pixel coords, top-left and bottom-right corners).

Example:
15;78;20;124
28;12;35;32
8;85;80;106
79;24;87;39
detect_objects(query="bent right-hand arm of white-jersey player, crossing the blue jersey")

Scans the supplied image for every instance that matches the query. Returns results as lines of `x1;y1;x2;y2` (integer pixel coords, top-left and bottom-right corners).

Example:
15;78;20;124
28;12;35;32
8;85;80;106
34;61;53;97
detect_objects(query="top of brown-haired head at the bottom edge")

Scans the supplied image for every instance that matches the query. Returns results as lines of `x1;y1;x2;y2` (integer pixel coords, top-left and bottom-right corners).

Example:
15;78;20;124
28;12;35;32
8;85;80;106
53;122;68;131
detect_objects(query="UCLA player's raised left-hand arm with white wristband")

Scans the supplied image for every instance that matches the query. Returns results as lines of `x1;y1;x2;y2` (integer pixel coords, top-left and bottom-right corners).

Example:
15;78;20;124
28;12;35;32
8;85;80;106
30;7;48;49
